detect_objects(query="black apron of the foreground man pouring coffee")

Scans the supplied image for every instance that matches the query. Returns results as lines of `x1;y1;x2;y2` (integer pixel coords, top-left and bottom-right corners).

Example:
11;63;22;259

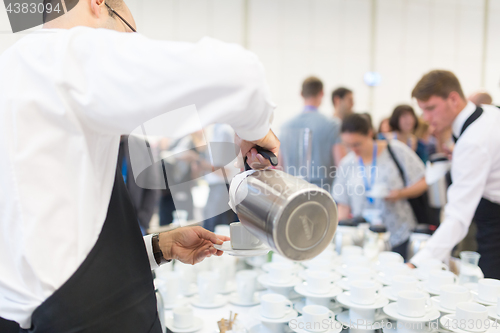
1;170;162;333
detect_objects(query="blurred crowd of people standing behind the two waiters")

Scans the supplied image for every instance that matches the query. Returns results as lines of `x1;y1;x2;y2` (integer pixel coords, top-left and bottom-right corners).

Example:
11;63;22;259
118;72;500;256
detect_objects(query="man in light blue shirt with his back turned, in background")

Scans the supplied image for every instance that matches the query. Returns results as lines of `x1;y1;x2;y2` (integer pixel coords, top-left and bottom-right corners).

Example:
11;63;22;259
280;76;345;190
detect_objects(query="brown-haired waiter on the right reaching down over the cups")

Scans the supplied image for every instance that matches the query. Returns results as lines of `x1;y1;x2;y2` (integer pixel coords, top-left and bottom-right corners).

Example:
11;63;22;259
411;70;500;279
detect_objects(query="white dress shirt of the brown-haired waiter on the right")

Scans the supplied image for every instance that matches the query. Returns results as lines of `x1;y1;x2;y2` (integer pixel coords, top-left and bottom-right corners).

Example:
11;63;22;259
411;102;500;266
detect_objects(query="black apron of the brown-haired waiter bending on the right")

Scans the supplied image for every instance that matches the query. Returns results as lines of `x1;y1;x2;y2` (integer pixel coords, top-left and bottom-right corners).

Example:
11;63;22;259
454;106;500;279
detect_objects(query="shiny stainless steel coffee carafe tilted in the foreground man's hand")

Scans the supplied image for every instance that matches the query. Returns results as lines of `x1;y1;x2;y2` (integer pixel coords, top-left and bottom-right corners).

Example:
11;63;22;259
229;151;338;261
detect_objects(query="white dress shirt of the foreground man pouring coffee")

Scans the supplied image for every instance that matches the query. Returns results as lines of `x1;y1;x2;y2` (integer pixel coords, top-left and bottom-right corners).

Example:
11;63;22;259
0;27;274;328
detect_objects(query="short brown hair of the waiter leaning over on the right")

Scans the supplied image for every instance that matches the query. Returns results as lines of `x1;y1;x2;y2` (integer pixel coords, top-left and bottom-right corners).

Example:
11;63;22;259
411;70;465;102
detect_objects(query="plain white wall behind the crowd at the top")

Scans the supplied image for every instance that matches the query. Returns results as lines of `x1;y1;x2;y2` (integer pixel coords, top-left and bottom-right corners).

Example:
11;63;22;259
0;0;500;130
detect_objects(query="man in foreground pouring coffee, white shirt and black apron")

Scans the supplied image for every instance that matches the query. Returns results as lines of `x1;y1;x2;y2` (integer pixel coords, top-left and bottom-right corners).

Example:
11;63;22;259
0;0;279;333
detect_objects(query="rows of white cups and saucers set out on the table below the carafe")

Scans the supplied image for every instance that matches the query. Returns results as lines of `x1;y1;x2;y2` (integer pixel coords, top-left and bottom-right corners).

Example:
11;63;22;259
159;246;500;333
